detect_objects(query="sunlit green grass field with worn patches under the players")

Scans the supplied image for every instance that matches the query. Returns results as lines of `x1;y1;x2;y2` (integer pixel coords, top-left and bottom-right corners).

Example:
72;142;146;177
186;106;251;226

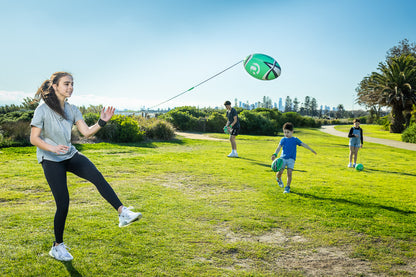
0;126;416;276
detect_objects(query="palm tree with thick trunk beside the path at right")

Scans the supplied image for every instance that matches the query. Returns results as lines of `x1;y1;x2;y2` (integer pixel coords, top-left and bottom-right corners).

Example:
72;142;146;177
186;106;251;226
368;55;416;133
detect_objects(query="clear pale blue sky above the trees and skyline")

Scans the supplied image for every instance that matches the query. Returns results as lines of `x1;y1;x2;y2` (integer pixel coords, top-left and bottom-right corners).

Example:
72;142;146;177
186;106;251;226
0;0;416;110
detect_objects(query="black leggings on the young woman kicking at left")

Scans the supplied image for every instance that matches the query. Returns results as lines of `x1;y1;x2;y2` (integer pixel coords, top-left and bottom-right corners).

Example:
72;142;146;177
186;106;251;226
42;153;122;243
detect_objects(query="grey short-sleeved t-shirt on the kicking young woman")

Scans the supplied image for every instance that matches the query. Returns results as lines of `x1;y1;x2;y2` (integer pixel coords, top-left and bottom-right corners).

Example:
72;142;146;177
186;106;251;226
30;103;83;163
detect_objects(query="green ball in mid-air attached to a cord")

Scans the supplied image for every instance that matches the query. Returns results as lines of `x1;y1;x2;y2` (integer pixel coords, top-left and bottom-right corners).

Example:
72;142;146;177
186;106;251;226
244;54;281;80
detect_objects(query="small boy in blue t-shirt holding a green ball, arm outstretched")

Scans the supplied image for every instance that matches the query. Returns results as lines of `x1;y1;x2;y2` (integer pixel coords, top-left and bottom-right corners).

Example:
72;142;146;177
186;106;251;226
272;122;316;193
